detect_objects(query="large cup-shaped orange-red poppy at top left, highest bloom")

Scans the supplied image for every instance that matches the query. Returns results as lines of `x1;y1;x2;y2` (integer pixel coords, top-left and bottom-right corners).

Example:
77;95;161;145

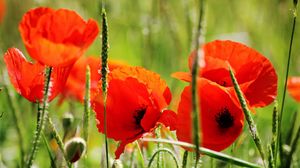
19;7;99;67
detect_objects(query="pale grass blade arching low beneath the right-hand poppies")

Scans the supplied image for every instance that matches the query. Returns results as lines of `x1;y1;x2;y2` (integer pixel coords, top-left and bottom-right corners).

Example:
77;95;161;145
141;138;261;168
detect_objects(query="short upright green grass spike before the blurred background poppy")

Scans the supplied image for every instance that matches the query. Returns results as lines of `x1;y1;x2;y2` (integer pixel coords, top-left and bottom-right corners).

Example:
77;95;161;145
83;66;91;149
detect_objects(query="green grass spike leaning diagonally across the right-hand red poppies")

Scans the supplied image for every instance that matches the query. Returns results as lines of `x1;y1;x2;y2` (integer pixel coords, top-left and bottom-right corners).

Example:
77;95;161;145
229;66;266;166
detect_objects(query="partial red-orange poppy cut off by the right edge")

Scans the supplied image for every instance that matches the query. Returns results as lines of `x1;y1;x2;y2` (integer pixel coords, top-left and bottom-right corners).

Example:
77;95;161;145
287;76;300;102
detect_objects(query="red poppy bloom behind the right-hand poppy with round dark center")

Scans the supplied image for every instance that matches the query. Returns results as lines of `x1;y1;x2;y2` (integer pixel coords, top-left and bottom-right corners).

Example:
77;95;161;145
173;40;277;107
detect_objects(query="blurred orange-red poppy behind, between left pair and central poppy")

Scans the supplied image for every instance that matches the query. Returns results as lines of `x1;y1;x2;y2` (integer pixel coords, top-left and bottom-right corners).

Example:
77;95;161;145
61;56;123;102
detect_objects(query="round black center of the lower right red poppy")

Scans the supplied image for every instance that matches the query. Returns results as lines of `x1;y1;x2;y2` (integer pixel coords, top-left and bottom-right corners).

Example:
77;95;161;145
215;108;234;128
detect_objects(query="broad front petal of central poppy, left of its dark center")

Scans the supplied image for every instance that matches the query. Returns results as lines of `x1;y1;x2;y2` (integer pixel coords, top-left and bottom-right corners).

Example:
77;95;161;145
93;78;150;141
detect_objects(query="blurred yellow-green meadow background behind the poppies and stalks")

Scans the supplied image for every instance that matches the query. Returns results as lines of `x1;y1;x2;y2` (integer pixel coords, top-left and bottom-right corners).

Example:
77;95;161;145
0;0;300;167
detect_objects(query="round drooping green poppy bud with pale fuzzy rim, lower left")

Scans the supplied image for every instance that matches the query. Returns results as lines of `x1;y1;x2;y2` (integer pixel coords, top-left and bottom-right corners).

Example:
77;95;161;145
65;137;86;163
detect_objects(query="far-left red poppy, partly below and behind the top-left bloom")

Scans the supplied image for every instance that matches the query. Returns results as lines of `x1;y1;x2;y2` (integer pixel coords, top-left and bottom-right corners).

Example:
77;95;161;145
4;48;70;102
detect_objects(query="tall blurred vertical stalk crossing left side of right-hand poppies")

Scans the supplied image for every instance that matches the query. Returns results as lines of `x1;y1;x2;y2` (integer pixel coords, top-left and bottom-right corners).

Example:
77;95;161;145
191;0;204;167
